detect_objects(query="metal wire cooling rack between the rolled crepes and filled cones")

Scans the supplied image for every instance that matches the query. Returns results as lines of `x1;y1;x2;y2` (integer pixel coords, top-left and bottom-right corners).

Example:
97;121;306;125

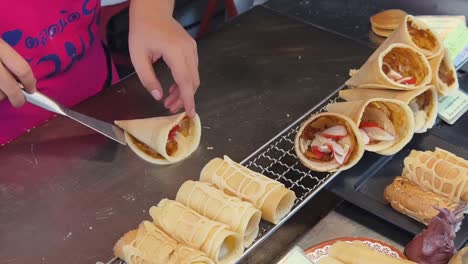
107;85;345;264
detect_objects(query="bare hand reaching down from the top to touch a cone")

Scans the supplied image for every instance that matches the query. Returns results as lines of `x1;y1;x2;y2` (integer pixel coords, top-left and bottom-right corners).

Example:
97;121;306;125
129;0;200;117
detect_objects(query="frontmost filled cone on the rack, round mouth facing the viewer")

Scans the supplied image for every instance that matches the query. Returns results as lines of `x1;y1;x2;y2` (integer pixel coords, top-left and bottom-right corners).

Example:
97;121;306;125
294;113;364;172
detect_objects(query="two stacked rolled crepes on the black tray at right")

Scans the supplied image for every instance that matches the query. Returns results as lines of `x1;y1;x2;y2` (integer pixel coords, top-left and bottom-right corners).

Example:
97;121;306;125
384;148;468;225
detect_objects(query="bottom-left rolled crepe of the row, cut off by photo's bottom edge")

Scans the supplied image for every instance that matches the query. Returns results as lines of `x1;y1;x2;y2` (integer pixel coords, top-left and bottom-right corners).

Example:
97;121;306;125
114;221;214;264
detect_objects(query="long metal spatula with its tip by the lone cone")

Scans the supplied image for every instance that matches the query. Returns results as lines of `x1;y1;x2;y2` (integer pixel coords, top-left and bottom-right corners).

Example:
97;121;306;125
20;87;127;145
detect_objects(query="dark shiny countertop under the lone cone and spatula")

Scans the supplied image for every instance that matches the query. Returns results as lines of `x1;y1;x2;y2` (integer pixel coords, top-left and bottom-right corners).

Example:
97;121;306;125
0;7;371;264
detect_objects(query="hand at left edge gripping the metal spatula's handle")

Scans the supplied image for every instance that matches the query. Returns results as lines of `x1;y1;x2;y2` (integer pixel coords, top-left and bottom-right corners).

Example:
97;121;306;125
0;38;36;107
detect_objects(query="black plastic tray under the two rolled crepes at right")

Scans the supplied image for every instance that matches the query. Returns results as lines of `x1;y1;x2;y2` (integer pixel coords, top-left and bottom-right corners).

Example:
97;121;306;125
327;115;468;249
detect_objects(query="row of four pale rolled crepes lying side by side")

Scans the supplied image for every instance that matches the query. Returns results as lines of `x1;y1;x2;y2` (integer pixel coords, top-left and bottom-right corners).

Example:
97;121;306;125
114;156;296;264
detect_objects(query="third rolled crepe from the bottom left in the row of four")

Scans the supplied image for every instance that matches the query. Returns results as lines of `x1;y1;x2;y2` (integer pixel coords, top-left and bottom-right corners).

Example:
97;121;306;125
176;181;262;247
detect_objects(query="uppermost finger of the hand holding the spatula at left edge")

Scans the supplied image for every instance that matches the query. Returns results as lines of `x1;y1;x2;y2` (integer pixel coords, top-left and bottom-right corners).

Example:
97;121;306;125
0;40;36;93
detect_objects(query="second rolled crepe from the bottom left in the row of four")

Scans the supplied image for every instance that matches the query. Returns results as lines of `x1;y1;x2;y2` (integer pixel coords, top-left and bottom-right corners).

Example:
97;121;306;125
150;199;244;263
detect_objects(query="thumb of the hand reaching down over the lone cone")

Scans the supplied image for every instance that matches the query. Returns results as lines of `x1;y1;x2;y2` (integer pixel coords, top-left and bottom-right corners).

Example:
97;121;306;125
131;49;163;101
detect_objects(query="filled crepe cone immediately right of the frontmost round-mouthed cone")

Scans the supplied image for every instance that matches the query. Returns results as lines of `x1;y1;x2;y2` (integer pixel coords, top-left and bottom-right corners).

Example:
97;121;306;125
327;98;414;155
